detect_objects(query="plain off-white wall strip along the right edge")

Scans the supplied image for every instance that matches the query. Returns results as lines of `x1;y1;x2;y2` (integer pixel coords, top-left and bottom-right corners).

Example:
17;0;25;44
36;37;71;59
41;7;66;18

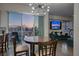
74;3;79;56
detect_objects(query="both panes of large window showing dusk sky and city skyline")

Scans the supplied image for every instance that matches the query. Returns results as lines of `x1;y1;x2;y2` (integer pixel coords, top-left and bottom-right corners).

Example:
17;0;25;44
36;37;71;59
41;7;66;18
9;12;34;41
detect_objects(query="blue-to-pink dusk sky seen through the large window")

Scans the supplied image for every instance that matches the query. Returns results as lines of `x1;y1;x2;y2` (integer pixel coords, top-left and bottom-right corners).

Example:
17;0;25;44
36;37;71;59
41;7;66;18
9;12;34;28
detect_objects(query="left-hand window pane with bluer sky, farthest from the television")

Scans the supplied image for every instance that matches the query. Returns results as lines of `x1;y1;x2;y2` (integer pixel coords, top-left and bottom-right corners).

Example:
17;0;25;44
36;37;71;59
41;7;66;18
9;12;22;42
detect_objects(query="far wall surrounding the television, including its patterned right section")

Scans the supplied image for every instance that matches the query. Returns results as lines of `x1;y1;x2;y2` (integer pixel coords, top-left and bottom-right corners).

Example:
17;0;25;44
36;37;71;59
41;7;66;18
49;15;73;36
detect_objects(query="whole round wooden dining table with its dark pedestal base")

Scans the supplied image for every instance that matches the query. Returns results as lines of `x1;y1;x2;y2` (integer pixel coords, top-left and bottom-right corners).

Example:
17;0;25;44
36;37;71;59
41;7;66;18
24;36;51;56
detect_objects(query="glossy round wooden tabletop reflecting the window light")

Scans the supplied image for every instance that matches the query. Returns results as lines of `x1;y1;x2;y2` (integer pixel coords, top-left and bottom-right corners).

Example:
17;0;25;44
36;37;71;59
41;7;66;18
24;36;51;44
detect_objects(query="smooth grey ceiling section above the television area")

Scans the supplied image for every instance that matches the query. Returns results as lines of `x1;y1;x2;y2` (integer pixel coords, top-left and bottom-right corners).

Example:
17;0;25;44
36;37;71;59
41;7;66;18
49;3;74;16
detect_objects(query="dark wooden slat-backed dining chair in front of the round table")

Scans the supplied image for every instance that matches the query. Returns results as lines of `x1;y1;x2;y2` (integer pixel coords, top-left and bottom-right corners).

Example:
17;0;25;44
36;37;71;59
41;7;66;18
35;40;57;56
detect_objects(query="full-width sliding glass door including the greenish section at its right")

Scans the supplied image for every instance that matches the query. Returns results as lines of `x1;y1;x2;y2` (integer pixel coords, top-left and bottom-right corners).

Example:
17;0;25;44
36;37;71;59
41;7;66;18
9;12;44;42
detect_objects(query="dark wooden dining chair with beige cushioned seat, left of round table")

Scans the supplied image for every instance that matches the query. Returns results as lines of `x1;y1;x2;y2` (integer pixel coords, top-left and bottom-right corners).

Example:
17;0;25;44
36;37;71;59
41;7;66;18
12;36;29;56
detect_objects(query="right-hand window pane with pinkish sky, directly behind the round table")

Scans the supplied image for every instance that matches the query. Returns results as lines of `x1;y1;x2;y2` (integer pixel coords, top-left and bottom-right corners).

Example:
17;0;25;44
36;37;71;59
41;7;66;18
22;14;34;36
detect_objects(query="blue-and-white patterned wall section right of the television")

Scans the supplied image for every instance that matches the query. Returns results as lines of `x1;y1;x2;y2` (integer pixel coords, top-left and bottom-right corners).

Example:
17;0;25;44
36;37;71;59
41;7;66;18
62;20;74;37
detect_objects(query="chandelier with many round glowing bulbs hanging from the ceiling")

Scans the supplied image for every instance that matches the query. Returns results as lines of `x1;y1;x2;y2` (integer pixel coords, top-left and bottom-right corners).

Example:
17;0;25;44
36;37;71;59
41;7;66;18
29;3;50;15
